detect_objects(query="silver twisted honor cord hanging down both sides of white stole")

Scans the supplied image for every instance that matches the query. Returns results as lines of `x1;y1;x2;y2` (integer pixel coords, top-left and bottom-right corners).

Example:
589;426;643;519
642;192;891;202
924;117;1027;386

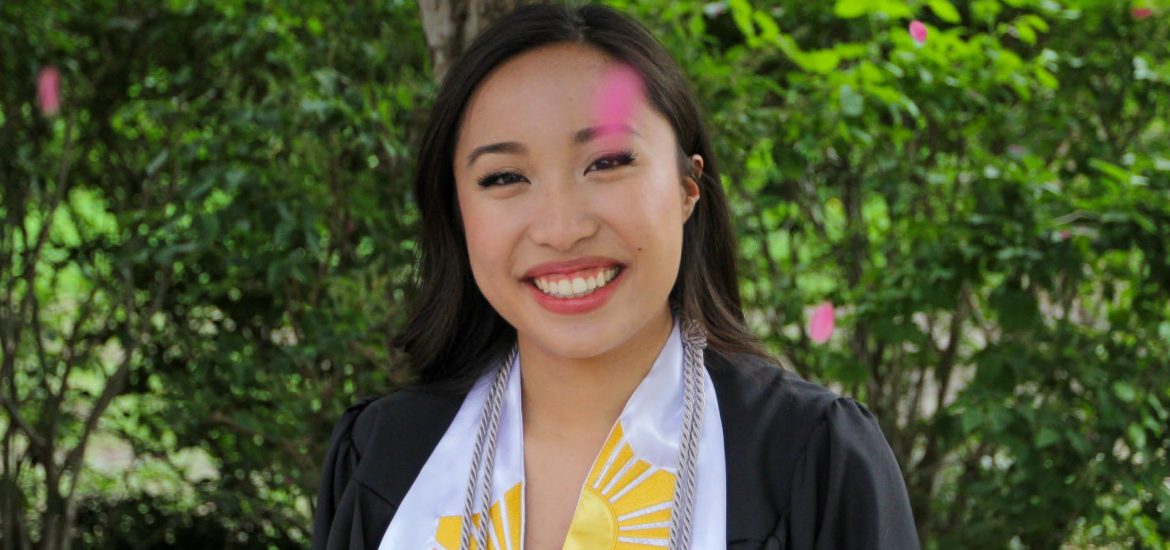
459;318;707;550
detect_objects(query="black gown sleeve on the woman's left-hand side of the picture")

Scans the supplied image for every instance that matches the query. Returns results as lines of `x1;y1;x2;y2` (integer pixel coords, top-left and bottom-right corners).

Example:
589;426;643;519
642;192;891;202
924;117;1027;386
311;398;393;550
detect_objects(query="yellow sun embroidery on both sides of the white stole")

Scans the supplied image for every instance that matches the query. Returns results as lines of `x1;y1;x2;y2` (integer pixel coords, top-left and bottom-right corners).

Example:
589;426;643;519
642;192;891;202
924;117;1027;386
435;422;675;550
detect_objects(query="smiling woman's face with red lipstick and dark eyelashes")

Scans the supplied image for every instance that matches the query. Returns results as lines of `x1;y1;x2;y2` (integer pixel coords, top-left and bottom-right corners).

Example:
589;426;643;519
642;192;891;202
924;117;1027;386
453;44;702;358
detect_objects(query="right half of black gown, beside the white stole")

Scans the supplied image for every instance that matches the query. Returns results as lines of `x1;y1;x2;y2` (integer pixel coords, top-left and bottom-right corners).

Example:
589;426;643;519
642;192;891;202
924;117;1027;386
707;353;918;549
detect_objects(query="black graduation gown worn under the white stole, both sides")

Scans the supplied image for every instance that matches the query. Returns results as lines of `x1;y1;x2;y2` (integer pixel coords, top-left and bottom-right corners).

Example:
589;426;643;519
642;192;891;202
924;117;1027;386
312;348;918;550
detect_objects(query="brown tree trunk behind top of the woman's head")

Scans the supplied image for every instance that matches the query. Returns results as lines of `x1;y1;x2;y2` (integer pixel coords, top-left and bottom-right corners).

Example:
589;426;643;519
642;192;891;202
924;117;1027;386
419;0;528;82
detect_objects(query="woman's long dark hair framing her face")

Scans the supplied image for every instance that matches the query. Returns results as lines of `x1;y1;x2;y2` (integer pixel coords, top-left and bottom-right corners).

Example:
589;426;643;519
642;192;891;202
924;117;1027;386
393;4;775;391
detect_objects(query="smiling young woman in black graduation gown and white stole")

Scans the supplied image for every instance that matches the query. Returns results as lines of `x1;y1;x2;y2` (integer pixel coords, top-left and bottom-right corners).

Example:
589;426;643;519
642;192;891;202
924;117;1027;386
312;5;918;550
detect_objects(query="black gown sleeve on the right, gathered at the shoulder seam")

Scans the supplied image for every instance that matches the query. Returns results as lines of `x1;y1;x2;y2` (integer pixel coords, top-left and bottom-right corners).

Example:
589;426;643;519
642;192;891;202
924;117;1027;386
777;398;920;550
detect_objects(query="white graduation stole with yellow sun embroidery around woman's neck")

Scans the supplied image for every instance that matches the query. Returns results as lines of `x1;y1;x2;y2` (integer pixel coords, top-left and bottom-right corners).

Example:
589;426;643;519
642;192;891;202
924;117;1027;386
376;318;727;550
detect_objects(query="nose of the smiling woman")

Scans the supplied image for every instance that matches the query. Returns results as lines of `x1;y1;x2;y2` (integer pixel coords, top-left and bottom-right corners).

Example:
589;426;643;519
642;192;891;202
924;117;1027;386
529;181;598;250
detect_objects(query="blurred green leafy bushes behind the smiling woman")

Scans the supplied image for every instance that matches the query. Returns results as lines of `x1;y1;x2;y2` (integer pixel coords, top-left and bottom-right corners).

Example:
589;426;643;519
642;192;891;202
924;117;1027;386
0;0;1170;550
